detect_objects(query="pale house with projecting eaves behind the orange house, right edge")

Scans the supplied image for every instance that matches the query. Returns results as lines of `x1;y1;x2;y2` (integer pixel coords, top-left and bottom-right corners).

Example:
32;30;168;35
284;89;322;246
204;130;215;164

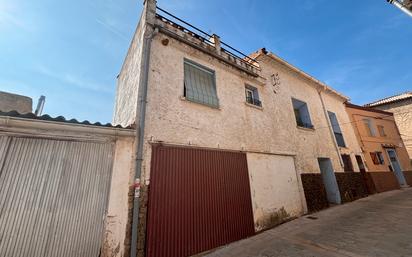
365;92;412;161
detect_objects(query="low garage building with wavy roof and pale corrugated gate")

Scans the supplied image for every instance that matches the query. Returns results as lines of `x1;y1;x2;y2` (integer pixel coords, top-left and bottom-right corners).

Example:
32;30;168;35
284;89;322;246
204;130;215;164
0;112;135;257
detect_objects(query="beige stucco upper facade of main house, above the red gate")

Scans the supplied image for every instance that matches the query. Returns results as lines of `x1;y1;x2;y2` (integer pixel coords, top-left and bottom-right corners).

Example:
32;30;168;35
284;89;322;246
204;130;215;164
121;33;360;180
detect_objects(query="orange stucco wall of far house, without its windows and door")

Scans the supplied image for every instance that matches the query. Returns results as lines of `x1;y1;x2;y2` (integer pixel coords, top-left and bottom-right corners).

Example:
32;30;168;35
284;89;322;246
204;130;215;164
347;105;412;171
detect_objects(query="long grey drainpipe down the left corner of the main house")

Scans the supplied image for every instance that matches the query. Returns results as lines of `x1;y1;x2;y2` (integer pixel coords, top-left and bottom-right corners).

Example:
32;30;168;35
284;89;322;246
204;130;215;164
130;0;158;257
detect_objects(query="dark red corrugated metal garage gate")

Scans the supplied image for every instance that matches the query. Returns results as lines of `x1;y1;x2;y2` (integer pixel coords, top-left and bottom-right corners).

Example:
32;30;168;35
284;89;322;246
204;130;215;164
147;145;254;257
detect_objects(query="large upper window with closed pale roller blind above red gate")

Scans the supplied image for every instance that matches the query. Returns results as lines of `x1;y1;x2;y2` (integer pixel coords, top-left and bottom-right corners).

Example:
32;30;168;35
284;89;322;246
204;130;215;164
184;59;219;107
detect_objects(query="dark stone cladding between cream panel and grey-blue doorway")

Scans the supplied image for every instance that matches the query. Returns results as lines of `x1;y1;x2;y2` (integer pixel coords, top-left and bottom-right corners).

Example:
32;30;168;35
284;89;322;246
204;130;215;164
301;173;329;212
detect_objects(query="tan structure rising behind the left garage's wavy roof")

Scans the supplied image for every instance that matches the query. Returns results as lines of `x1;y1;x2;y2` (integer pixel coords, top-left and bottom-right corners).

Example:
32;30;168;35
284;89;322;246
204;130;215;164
0;91;33;113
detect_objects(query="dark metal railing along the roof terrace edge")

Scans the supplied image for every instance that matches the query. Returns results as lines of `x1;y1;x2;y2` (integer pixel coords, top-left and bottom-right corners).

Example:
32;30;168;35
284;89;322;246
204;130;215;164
156;6;259;69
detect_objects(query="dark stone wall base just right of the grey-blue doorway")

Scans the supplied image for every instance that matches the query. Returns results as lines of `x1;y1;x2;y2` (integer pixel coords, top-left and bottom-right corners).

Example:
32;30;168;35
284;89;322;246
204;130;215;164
335;172;368;203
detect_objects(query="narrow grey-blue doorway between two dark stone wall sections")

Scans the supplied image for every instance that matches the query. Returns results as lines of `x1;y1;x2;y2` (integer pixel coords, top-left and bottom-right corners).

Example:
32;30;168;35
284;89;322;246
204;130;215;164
318;158;342;204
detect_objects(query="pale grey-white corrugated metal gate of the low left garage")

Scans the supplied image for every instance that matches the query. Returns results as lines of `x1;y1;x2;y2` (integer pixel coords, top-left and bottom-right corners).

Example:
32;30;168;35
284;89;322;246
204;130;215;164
0;136;113;257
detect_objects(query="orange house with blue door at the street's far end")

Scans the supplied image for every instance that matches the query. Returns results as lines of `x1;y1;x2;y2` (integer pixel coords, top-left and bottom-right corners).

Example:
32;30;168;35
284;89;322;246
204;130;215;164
346;103;412;191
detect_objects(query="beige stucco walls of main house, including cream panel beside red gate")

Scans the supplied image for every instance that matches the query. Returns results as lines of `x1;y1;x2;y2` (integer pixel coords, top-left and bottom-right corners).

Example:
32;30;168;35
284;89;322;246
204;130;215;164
114;4;361;234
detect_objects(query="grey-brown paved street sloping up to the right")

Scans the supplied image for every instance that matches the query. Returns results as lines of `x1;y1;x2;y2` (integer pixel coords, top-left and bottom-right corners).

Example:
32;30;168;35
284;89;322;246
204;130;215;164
207;189;412;257
